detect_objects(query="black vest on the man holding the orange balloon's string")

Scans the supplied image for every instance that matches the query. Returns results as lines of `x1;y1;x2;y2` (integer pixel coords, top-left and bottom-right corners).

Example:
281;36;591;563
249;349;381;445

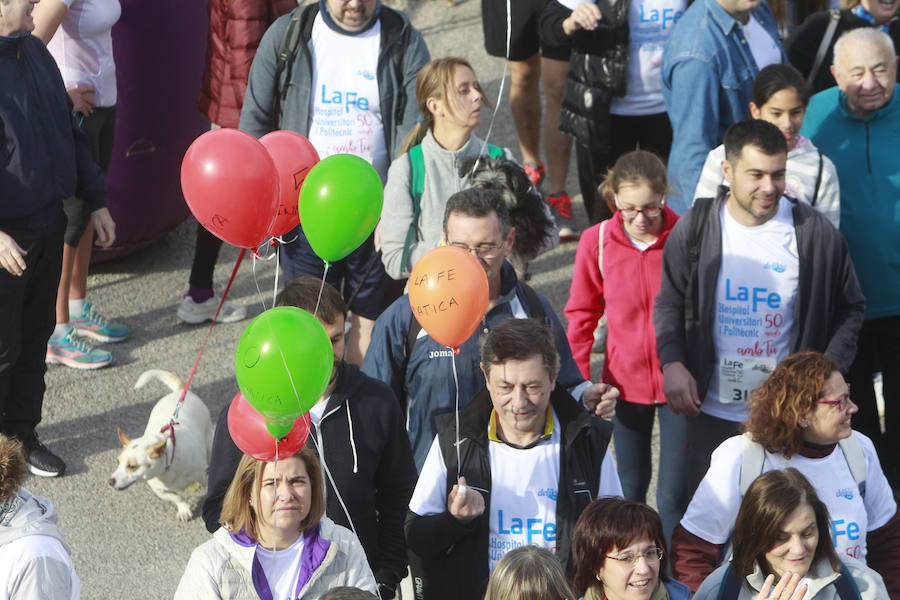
406;385;612;600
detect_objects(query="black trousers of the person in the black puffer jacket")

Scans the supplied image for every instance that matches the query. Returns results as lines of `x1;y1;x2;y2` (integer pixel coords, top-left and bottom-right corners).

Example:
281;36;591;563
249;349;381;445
575;113;672;225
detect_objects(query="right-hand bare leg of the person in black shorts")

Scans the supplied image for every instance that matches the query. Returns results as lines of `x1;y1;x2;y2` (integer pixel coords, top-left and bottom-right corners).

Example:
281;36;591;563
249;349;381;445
541;58;572;194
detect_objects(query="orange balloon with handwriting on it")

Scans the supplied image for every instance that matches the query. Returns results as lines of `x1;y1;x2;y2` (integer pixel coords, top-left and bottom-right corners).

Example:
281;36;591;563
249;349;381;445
409;246;490;348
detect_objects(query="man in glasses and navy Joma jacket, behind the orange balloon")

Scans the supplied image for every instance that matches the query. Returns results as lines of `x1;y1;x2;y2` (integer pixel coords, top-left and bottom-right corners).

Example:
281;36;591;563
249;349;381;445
363;188;618;470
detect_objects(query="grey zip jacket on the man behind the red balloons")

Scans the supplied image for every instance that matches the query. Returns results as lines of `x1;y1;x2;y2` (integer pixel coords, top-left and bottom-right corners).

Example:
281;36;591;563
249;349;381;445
239;4;430;163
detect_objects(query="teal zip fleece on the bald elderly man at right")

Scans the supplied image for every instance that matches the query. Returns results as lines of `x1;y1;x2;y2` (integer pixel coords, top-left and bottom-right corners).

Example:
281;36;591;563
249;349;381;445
800;84;900;319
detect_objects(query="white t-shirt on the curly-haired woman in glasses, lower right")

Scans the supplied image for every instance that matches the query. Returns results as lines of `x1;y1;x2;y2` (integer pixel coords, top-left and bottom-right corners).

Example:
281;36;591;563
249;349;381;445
681;431;897;562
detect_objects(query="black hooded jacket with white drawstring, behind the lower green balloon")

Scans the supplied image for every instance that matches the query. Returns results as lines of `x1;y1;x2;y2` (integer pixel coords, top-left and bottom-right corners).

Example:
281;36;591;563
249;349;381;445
203;363;416;587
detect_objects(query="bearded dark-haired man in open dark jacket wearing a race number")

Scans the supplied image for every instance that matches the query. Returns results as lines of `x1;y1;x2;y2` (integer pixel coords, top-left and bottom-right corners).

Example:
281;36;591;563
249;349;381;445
653;119;865;506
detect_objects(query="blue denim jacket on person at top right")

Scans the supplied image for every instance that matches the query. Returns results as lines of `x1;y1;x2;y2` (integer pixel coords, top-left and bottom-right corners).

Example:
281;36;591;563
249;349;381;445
662;0;784;214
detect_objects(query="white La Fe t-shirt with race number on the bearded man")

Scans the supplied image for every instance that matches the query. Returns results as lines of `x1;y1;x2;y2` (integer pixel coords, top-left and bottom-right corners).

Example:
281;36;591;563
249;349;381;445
700;198;800;421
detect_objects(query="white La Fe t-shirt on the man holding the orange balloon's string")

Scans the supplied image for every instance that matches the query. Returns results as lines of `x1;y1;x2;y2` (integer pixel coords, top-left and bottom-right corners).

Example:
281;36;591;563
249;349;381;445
409;414;622;570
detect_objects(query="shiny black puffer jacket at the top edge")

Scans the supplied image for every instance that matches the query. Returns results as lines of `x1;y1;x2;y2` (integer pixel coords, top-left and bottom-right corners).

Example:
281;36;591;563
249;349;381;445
540;0;631;152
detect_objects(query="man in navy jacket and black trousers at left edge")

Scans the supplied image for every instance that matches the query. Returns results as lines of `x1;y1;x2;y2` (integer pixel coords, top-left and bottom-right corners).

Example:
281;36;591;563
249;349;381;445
0;0;115;477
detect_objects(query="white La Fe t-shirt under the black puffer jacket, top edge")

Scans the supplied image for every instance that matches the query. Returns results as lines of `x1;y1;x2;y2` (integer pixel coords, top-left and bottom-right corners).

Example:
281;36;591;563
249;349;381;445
610;0;687;115
